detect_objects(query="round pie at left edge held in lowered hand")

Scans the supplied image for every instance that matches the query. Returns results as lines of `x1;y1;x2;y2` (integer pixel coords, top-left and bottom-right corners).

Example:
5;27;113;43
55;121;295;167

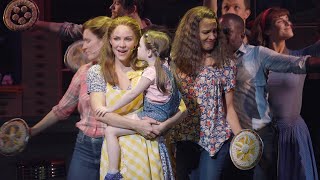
0;118;29;156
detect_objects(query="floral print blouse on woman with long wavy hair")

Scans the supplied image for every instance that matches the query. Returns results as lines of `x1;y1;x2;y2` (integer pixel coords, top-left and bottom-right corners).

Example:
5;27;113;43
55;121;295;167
171;66;235;156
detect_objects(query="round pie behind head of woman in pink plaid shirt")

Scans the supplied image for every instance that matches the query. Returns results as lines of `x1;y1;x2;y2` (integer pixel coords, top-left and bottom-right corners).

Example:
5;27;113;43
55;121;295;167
64;40;90;72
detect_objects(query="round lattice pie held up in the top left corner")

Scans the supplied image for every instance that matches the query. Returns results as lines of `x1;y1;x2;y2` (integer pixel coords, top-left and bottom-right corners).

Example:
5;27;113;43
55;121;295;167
3;0;39;31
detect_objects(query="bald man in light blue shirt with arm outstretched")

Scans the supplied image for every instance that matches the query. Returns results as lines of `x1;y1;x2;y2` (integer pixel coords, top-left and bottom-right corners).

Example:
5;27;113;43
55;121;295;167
219;14;320;180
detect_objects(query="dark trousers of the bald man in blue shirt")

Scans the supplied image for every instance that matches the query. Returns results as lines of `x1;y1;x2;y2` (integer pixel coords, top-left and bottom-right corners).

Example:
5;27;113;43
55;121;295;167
223;124;278;180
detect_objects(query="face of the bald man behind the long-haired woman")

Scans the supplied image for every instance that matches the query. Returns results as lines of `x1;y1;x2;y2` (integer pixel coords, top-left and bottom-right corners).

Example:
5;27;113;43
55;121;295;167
220;18;244;51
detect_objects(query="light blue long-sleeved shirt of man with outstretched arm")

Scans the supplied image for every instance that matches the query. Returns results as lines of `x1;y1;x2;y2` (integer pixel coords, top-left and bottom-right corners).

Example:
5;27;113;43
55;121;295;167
233;44;308;130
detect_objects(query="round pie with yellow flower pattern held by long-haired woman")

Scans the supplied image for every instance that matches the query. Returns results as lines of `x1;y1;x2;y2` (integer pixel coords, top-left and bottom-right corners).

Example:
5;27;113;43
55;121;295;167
230;129;263;170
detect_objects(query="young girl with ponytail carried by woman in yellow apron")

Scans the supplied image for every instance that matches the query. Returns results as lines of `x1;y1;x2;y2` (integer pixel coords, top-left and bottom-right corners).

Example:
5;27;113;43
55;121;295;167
96;30;181;179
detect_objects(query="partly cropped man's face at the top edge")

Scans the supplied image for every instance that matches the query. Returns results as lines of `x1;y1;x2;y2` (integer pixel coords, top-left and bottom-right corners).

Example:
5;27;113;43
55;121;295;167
221;0;251;21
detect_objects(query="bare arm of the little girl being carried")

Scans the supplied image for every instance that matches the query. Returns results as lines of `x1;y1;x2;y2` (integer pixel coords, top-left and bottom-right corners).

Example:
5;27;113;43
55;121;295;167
107;77;152;112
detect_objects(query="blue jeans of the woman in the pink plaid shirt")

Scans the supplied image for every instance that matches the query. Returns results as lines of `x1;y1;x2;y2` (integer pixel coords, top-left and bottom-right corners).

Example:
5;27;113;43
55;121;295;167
68;131;103;180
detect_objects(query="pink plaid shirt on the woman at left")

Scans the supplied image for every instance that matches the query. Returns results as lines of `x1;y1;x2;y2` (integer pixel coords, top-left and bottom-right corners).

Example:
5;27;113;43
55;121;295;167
52;63;105;138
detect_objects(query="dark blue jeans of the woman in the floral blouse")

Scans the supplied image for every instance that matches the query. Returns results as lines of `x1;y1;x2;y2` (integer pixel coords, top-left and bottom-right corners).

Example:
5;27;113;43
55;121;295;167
176;141;230;180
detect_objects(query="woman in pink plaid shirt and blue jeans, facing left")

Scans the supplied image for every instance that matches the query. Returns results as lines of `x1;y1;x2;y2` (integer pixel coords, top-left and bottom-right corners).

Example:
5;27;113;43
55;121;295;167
30;16;111;180
